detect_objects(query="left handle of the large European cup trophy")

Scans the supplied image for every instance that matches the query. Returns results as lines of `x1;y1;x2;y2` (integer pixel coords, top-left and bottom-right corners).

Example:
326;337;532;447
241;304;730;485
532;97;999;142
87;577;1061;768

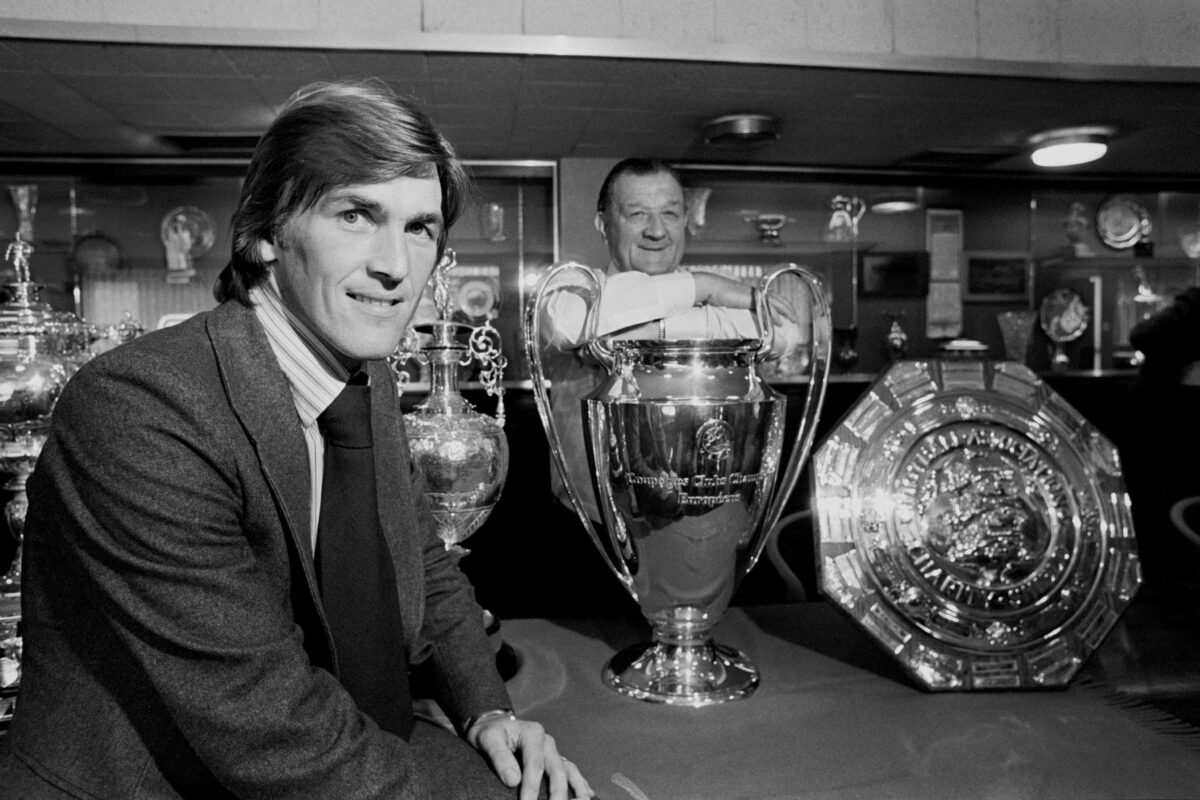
524;261;631;587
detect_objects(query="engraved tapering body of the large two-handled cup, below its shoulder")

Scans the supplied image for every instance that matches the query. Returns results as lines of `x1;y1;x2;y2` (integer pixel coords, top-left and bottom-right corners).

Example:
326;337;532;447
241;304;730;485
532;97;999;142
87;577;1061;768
588;399;781;616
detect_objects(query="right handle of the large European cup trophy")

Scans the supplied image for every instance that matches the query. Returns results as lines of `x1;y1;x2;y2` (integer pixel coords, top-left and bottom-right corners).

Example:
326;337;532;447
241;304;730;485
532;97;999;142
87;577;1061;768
750;264;833;551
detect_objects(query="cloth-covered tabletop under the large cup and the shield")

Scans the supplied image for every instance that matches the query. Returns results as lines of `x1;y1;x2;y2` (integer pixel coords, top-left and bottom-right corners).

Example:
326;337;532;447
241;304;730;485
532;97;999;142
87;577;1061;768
502;596;1200;800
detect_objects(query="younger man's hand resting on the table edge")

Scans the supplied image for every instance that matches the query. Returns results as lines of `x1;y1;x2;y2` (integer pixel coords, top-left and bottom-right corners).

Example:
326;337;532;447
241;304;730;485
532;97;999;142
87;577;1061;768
466;717;594;800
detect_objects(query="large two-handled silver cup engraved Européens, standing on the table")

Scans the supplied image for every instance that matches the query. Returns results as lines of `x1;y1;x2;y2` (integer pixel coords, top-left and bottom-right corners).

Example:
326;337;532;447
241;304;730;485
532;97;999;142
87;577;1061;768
524;261;832;706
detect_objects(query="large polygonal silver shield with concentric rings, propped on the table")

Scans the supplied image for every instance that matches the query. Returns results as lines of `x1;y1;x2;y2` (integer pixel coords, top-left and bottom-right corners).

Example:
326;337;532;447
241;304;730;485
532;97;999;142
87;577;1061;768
812;361;1141;691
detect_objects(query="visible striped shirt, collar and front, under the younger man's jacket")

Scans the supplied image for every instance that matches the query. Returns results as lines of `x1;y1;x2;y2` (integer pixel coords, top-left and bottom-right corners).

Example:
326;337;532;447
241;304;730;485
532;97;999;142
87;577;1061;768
250;273;350;553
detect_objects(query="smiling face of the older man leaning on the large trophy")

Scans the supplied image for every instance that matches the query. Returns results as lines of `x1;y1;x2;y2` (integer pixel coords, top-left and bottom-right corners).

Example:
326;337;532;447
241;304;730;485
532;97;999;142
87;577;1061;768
596;173;686;275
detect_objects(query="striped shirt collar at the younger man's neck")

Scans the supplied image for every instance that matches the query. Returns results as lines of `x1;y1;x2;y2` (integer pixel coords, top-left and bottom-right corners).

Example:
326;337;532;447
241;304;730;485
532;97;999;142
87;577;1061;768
250;273;350;426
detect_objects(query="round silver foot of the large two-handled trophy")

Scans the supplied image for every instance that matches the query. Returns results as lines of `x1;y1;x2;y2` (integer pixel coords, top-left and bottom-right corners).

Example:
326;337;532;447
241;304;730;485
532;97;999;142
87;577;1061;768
604;639;758;708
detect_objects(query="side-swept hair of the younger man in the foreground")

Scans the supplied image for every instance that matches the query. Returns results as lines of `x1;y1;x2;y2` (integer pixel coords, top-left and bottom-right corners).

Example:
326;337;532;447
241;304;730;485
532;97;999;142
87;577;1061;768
212;80;469;305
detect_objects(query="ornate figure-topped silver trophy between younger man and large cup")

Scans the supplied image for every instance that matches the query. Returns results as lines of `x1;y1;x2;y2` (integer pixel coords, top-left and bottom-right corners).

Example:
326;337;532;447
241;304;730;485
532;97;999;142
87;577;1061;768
389;249;509;555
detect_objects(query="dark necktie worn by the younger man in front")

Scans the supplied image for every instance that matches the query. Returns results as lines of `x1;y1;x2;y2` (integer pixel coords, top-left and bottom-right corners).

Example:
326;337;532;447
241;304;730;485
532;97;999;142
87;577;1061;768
317;372;413;739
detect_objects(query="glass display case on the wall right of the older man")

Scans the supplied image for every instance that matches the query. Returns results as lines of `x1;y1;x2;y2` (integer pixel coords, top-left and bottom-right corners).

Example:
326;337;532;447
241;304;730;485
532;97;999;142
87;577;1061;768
679;164;1200;375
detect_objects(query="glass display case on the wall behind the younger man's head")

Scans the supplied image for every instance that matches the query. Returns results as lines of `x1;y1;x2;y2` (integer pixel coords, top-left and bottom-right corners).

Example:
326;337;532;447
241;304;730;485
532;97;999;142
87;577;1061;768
0;161;558;380
